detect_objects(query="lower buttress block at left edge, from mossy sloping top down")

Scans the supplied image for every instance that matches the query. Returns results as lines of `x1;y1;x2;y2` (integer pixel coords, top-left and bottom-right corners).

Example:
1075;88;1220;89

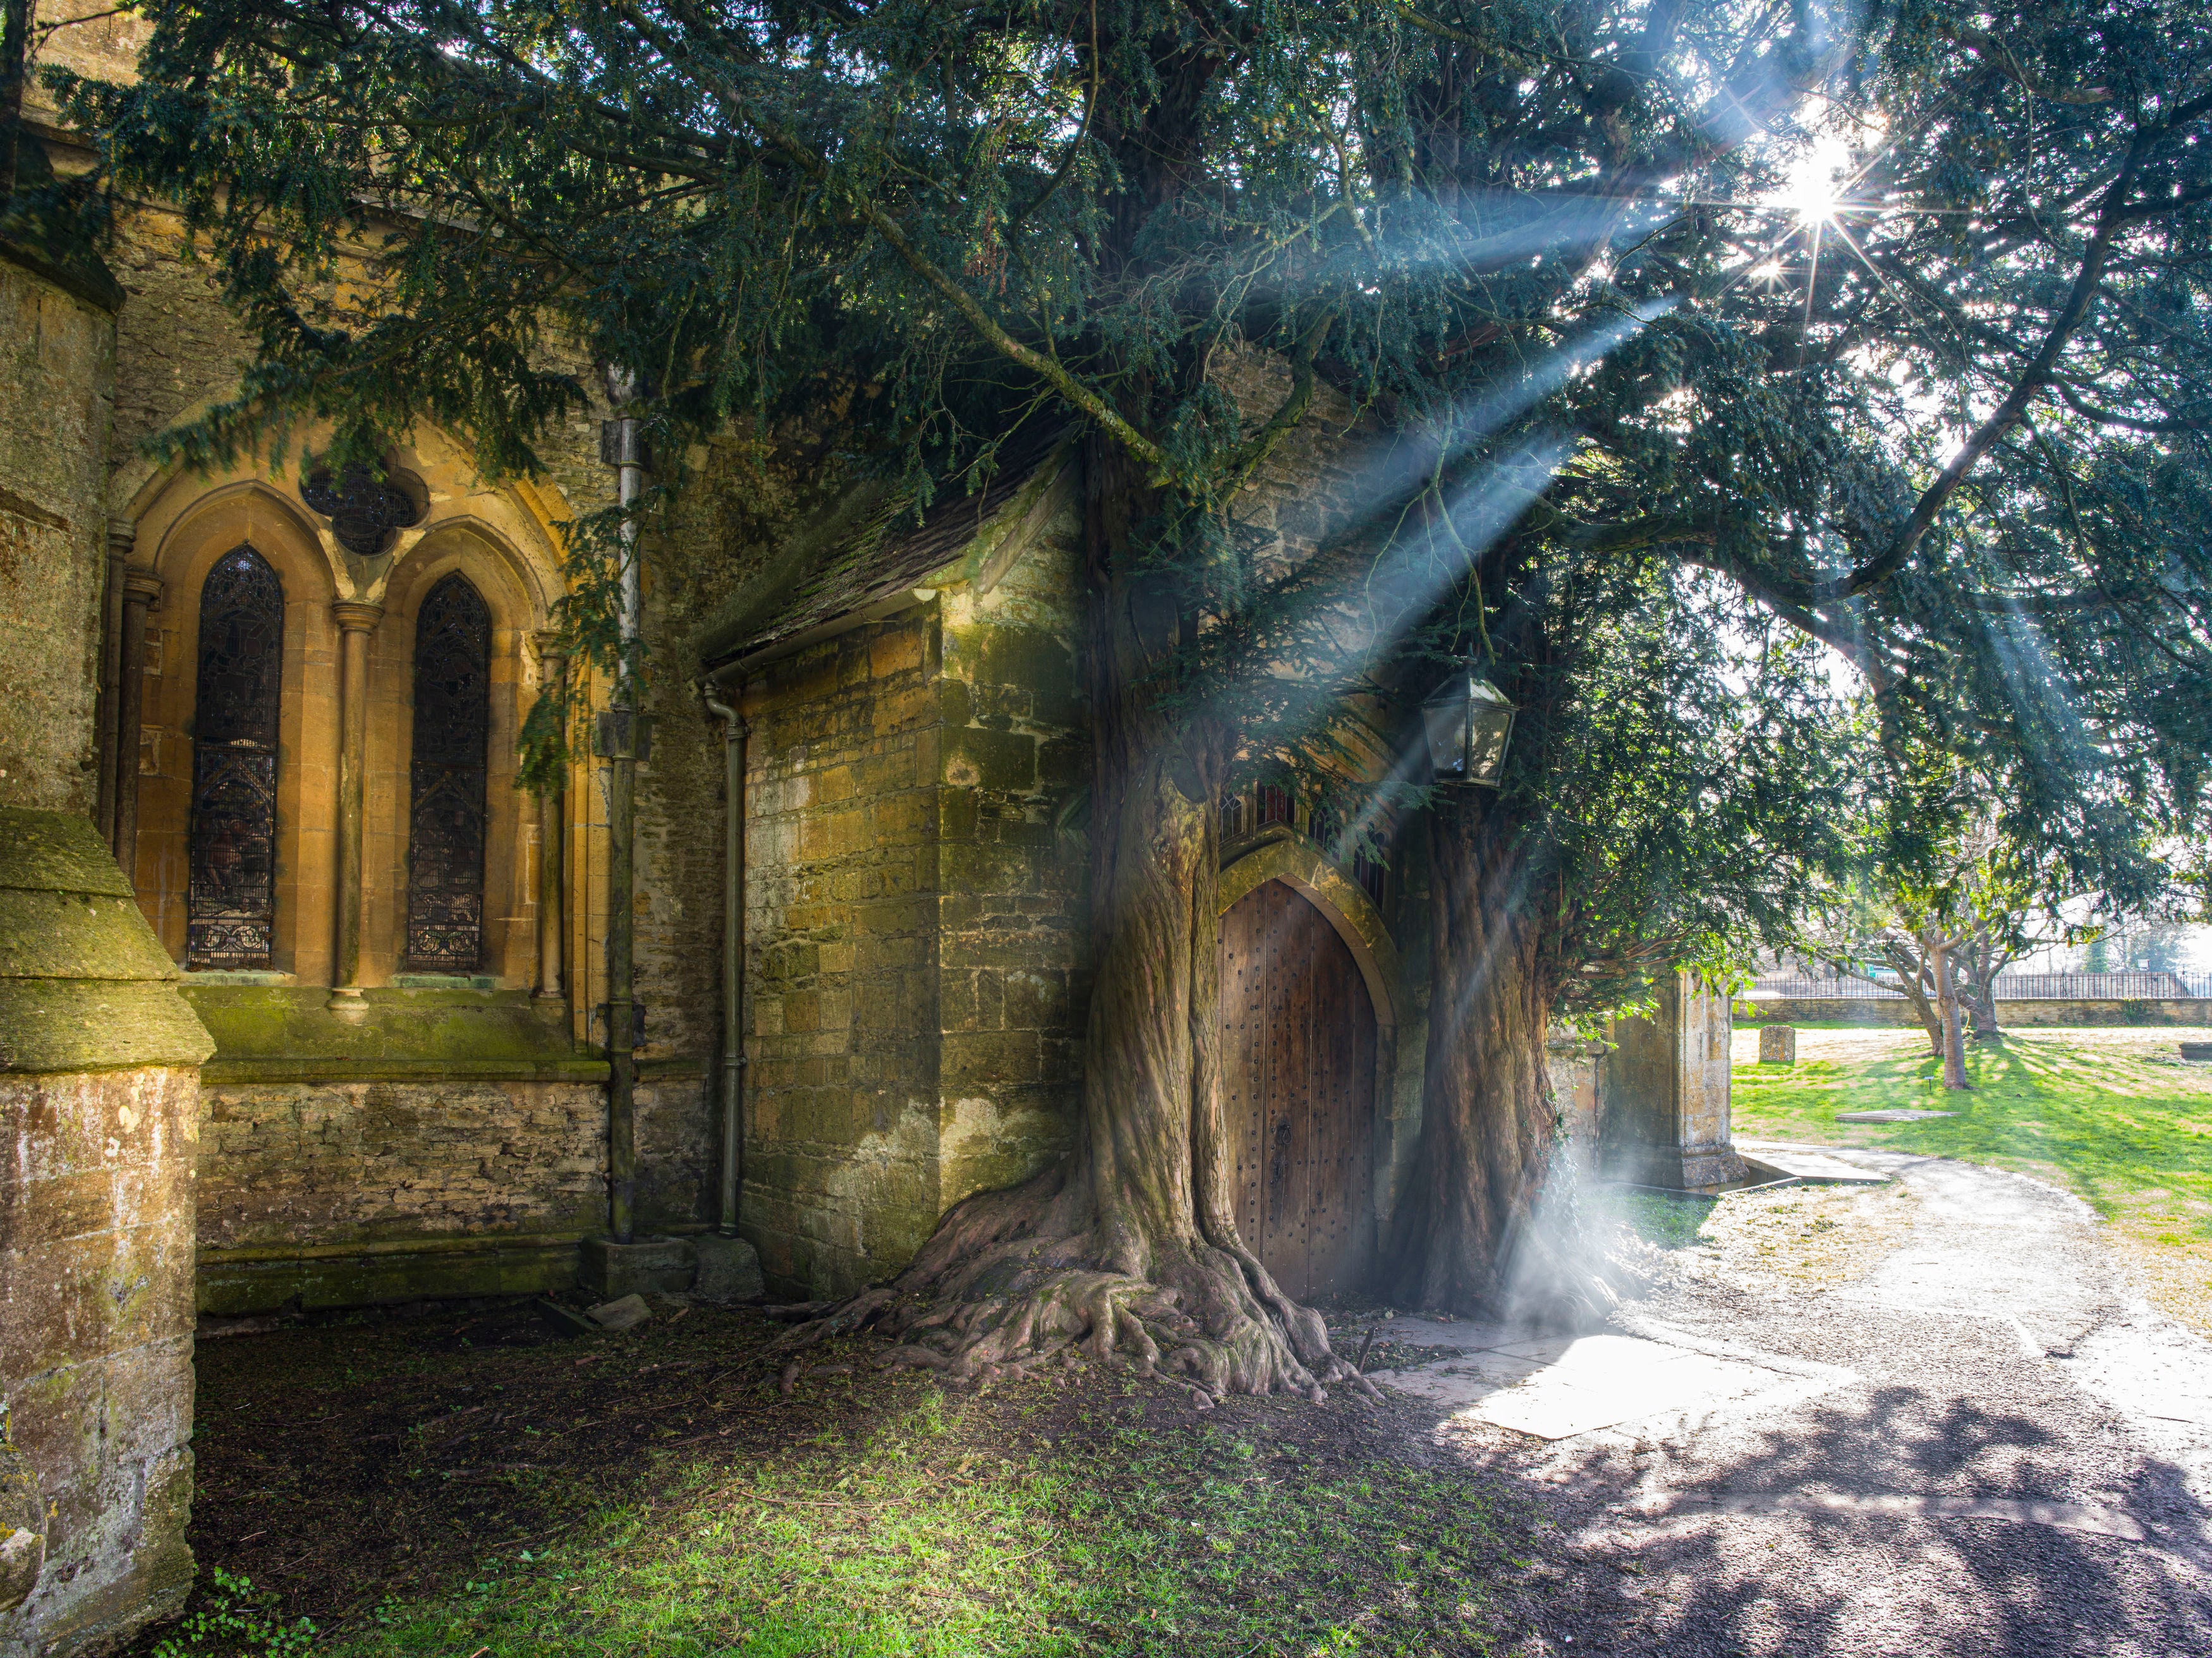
0;813;212;1658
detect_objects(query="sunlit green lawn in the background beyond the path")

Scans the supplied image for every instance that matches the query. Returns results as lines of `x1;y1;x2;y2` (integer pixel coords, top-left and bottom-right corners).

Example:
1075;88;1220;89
1734;1026;2212;1335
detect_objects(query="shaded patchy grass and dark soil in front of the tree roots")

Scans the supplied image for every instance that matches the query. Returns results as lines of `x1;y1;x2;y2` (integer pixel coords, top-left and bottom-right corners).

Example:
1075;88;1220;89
135;1307;1533;1658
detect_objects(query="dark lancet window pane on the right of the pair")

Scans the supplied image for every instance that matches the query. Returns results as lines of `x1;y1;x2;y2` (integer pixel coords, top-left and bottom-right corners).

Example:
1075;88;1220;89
407;575;491;972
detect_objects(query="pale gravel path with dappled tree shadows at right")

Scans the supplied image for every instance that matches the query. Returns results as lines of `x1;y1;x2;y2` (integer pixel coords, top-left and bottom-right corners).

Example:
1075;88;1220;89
1438;1147;2212;1658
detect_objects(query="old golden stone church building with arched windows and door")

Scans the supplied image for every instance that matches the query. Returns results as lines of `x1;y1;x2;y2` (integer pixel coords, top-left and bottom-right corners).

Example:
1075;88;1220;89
0;0;1732;1658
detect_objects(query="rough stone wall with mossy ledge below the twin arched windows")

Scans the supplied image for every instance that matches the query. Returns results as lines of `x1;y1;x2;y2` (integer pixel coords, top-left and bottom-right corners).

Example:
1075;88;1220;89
188;984;708;1313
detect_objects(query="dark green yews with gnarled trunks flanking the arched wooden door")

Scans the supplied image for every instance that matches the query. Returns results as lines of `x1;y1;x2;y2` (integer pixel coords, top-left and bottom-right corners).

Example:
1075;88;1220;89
69;0;2212;1391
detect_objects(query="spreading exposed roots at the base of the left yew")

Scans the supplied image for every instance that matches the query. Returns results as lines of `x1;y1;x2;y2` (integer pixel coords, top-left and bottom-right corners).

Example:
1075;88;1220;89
783;1171;1374;1410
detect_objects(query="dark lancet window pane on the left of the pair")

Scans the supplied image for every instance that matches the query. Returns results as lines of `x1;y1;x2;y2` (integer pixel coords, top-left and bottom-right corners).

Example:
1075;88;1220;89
184;546;283;968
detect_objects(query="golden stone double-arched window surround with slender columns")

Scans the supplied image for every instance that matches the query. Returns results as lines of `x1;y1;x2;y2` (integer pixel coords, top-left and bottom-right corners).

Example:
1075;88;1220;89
115;431;571;995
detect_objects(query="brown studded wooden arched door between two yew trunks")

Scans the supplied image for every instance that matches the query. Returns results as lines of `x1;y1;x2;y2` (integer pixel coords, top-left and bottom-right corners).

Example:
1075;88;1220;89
1221;880;1376;1300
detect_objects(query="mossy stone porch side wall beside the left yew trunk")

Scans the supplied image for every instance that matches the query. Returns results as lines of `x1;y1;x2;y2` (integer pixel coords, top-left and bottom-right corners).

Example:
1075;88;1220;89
743;509;1086;1295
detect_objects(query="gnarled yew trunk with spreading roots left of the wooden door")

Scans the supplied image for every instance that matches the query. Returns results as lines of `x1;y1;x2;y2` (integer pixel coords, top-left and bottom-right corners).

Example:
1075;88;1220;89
786;444;1352;1400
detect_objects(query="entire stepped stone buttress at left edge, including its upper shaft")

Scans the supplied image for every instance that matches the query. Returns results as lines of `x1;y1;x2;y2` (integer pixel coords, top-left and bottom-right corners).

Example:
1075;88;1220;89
0;198;210;1658
